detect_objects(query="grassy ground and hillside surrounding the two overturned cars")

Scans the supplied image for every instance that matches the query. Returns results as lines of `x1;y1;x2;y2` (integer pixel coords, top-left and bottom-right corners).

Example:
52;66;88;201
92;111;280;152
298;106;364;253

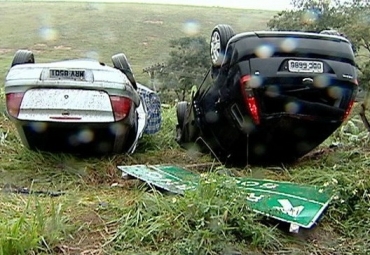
0;1;370;255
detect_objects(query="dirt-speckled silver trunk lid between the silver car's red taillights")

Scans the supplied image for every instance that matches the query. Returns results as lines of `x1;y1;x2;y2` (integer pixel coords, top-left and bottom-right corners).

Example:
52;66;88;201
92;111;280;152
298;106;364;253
18;88;114;122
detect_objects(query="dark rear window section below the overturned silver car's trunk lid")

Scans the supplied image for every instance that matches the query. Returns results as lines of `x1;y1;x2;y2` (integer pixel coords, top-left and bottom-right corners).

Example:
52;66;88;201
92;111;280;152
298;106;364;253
11;118;136;154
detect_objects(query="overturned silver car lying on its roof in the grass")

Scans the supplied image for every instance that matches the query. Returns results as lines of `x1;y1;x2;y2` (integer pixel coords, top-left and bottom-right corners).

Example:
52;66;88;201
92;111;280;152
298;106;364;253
5;50;161;154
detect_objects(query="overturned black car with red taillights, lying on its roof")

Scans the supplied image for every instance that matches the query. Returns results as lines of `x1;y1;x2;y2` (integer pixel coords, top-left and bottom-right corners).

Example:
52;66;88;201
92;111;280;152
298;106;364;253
176;25;358;165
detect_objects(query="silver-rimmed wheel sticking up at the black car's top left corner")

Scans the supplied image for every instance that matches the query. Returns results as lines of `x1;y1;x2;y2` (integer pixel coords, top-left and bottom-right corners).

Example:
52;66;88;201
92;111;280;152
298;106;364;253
210;24;235;67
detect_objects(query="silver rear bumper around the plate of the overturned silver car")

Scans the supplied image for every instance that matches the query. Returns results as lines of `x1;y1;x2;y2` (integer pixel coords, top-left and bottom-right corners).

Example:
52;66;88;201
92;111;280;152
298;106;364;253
5;59;140;105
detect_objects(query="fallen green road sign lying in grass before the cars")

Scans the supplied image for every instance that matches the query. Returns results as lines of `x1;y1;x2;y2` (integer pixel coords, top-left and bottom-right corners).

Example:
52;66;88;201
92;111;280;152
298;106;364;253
118;165;332;232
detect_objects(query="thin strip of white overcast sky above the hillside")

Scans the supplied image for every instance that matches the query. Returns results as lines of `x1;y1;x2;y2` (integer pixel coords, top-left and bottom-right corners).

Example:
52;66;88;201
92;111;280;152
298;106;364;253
110;0;291;10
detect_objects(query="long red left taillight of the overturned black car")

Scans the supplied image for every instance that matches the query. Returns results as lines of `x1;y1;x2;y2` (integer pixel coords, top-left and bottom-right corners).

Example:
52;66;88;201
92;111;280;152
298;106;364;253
240;75;260;124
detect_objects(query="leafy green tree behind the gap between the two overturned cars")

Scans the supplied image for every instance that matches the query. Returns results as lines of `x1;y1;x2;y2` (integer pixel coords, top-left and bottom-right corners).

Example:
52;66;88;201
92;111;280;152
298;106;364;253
159;37;210;101
